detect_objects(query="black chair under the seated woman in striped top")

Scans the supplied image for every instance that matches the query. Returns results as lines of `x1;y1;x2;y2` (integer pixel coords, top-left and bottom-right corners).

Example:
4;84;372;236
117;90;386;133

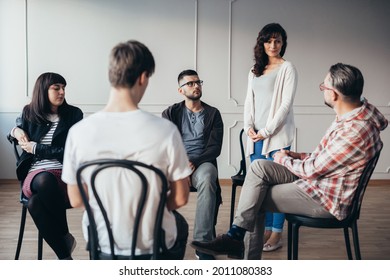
7;134;43;260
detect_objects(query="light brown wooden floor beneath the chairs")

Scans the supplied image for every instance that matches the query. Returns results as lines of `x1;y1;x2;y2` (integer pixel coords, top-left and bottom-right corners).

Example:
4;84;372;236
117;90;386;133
0;180;390;260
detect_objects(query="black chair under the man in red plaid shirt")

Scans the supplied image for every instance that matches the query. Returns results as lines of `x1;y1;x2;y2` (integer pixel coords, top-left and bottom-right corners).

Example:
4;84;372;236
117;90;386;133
286;151;380;260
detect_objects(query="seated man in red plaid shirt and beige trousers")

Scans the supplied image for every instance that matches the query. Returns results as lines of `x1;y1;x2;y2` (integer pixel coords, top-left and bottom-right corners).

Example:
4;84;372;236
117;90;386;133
191;63;388;259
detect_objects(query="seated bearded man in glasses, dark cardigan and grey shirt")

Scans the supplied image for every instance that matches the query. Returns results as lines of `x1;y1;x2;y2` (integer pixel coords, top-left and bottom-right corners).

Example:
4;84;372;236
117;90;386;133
162;70;223;260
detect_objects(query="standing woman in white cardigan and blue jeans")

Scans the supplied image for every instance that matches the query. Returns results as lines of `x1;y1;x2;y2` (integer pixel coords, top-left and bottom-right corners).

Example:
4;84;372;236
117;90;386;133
244;23;298;252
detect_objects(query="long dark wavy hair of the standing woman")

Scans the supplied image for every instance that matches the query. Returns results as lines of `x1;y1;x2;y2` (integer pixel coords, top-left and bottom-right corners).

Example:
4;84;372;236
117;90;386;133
252;23;287;77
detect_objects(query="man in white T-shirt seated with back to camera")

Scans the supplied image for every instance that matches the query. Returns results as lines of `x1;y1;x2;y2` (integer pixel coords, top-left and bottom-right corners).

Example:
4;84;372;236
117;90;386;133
62;40;191;259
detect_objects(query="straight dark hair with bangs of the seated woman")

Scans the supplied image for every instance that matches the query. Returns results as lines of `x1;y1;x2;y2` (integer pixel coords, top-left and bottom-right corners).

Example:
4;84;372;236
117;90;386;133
23;72;68;123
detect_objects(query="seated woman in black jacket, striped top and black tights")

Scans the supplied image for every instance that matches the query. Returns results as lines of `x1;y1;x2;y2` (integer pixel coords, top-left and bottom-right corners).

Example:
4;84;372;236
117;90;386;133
11;73;83;259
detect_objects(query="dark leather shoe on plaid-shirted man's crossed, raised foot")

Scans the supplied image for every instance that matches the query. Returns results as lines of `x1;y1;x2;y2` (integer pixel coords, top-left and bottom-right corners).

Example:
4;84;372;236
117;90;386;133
191;234;244;259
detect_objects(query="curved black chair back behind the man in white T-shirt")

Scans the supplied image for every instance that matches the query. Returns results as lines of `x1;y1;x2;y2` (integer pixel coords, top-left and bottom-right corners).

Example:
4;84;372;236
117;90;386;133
77;159;168;259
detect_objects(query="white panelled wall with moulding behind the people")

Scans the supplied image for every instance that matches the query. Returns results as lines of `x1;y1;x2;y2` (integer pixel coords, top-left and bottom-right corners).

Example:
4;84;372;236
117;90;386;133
0;0;390;179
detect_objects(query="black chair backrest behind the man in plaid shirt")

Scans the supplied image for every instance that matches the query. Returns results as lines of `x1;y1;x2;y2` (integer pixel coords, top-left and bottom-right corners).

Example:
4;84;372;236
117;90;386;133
347;147;382;222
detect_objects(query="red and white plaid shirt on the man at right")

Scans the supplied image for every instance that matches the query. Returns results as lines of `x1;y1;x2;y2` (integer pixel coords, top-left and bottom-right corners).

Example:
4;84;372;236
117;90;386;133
278;100;388;220
